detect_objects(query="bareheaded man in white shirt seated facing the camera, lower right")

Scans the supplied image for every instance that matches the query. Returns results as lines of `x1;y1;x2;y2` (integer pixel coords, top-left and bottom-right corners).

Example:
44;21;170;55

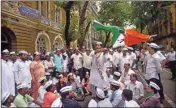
126;74;144;104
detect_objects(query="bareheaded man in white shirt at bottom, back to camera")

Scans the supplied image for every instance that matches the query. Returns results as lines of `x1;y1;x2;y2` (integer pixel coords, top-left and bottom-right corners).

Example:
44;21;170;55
122;89;140;108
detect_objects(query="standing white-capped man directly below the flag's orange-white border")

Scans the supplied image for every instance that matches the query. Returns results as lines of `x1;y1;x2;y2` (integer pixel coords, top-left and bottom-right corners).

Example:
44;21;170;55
119;48;130;75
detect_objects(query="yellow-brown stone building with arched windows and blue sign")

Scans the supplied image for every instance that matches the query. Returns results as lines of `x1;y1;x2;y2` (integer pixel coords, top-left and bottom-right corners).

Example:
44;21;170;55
1;1;65;53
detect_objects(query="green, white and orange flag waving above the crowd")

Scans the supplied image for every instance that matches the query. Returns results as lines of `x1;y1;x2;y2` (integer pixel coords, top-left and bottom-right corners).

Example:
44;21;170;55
92;20;151;48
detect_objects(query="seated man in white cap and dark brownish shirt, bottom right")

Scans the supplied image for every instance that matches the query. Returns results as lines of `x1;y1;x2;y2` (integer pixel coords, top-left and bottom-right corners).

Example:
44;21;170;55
140;81;160;108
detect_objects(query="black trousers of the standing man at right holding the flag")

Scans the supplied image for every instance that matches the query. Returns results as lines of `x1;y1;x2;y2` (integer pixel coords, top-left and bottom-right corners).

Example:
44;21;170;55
147;77;164;100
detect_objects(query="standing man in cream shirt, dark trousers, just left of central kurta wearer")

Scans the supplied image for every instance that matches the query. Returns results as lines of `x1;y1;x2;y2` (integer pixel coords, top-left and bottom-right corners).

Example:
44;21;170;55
81;48;92;77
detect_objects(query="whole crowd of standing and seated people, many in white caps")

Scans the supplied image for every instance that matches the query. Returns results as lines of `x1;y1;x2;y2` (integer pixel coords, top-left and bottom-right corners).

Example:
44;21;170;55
1;42;176;108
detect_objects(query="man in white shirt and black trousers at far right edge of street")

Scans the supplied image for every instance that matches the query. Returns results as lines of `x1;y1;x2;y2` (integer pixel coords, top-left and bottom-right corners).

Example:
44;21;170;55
168;48;176;80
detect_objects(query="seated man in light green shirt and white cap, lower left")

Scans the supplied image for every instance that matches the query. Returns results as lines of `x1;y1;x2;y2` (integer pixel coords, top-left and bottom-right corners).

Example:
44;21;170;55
14;83;41;107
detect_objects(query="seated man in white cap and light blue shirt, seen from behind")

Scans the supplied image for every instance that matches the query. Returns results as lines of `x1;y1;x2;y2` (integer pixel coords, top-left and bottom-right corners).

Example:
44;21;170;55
110;80;124;107
